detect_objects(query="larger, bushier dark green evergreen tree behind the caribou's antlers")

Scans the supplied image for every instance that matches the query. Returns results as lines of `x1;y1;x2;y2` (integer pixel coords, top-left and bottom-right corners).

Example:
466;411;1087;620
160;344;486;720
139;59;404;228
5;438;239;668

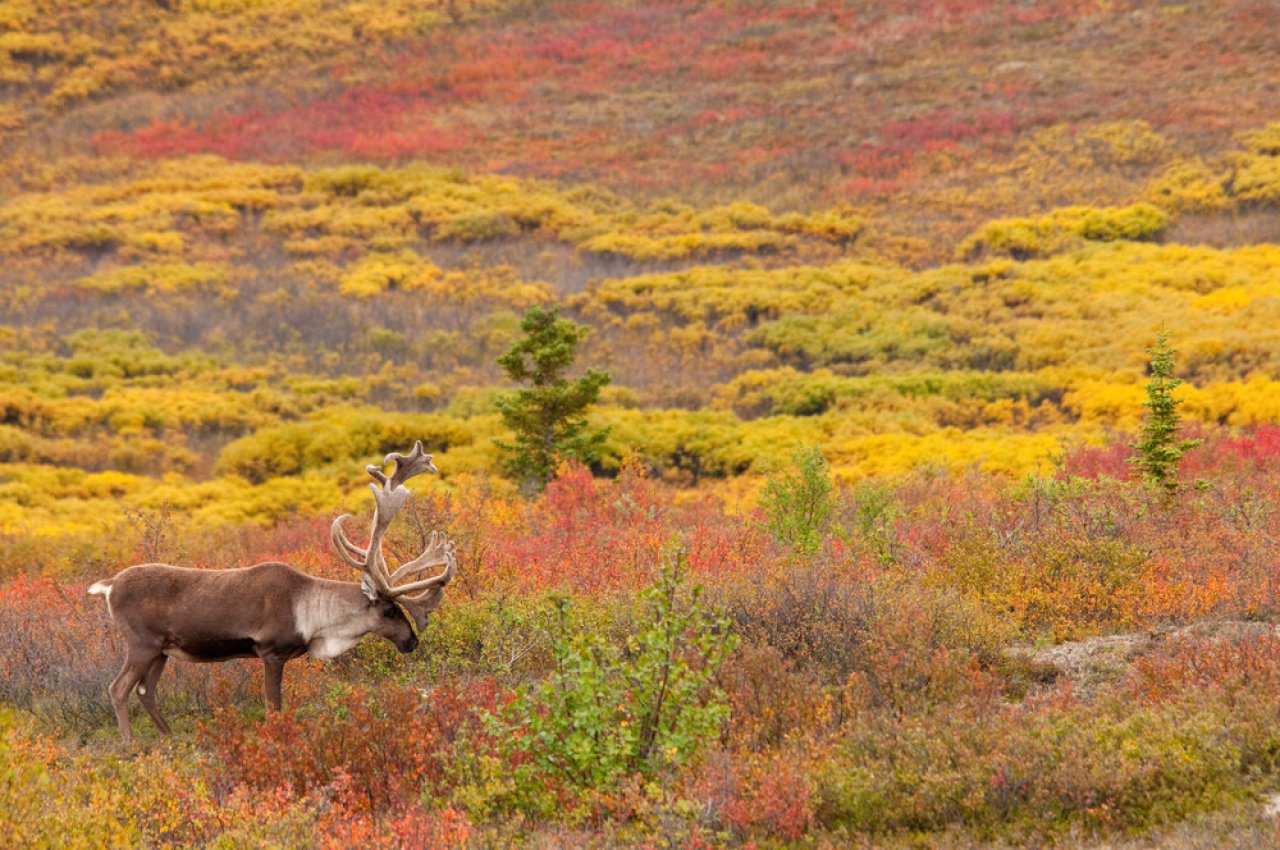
495;307;611;492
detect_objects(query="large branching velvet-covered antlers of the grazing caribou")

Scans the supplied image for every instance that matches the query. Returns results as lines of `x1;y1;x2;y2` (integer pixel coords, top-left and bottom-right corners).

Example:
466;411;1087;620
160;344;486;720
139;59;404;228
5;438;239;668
329;440;457;611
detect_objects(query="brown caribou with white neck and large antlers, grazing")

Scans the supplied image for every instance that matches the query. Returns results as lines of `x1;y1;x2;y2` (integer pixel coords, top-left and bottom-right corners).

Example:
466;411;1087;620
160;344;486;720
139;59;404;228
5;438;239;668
88;440;457;746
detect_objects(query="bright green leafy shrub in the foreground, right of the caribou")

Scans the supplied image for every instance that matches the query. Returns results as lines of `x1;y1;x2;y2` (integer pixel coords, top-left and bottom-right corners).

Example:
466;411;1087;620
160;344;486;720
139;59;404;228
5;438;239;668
486;557;737;819
